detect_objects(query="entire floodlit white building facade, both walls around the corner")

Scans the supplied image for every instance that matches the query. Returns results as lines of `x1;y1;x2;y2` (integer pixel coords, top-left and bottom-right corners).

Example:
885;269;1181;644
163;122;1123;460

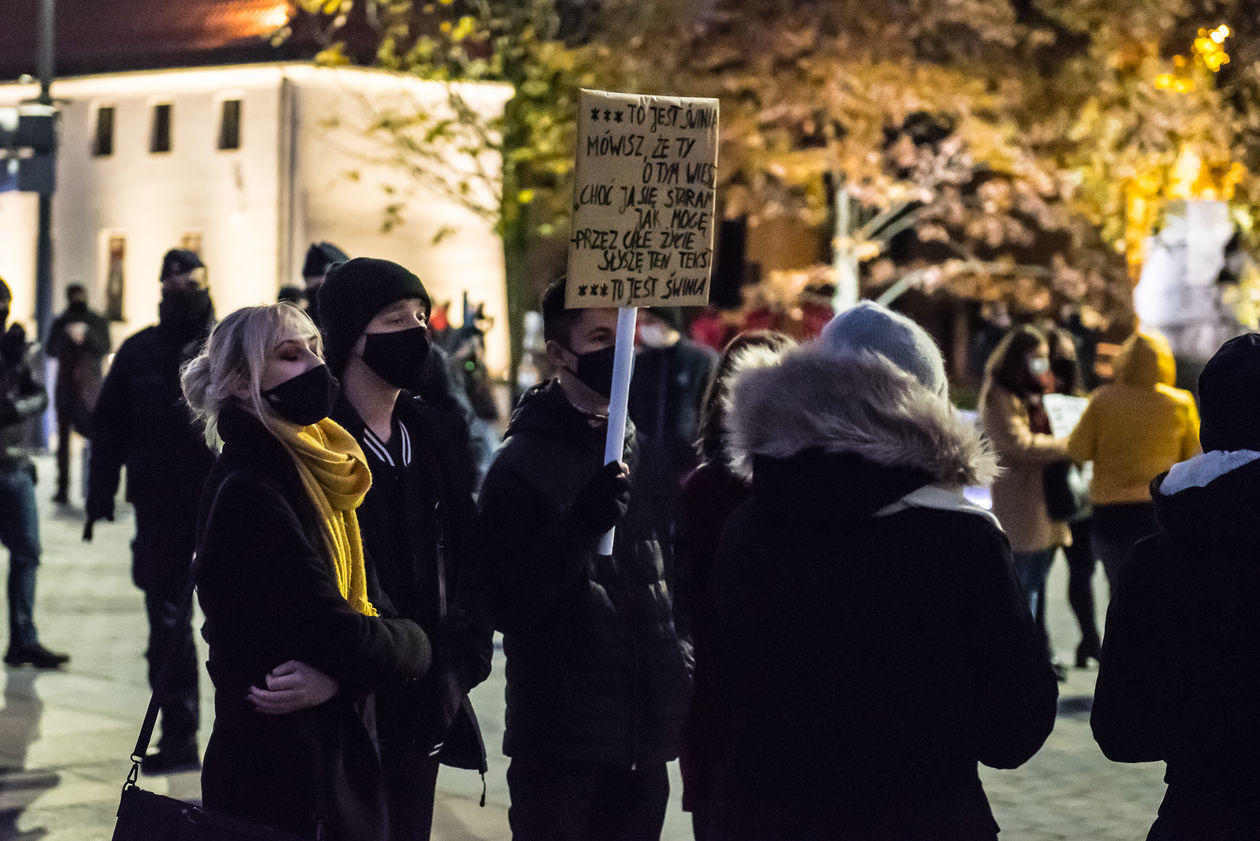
0;63;510;372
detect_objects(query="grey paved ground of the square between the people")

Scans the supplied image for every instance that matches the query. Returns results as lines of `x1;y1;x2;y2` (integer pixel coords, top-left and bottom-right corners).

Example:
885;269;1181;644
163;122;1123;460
0;459;1163;841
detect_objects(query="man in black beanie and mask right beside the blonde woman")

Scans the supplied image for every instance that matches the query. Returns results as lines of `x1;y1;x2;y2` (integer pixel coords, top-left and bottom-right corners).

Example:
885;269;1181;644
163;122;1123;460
319;257;494;841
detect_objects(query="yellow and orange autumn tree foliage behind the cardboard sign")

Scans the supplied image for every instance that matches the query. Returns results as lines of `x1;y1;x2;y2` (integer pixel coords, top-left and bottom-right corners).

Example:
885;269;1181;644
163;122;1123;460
288;0;1260;370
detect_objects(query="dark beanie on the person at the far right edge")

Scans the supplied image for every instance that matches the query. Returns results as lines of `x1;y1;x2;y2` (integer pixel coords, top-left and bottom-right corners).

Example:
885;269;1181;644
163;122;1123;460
1198;333;1260;450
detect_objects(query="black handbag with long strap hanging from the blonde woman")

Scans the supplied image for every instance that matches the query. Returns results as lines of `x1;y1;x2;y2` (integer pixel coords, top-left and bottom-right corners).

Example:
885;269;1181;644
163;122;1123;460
112;477;323;841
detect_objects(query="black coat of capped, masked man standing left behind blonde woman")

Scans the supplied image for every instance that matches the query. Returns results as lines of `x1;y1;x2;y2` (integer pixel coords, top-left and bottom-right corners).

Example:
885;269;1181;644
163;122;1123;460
87;323;214;574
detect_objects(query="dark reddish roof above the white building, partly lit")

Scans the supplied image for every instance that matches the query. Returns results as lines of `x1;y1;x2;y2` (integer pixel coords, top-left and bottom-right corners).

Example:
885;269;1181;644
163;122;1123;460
0;0;330;81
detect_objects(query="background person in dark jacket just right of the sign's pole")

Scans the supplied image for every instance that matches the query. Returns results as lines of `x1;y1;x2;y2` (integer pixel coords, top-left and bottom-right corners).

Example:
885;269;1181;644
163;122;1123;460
630;306;717;482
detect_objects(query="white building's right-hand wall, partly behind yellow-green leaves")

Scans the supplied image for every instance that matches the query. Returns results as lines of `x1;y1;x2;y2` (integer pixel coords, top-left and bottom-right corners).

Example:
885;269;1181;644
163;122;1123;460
290;67;512;373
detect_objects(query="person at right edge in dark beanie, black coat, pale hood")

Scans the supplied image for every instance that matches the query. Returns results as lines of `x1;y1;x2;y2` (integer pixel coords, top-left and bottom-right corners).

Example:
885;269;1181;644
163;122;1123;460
1090;333;1260;841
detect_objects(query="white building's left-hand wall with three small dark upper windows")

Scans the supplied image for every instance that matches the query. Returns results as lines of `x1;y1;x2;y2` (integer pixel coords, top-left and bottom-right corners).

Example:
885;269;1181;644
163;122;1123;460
0;66;281;335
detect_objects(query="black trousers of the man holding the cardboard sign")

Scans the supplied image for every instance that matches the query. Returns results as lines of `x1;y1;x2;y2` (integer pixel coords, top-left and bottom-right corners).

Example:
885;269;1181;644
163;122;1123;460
508;757;669;841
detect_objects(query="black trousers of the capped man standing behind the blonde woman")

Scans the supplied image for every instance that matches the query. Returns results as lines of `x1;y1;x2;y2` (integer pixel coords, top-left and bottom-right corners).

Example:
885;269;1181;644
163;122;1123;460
131;503;200;748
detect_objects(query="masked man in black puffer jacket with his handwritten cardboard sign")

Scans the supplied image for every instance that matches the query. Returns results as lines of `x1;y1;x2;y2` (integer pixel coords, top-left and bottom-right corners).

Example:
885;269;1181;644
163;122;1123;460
478;91;717;841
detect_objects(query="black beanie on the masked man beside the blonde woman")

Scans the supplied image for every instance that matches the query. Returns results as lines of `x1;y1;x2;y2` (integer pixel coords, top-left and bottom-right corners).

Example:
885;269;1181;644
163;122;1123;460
319;257;433;376
